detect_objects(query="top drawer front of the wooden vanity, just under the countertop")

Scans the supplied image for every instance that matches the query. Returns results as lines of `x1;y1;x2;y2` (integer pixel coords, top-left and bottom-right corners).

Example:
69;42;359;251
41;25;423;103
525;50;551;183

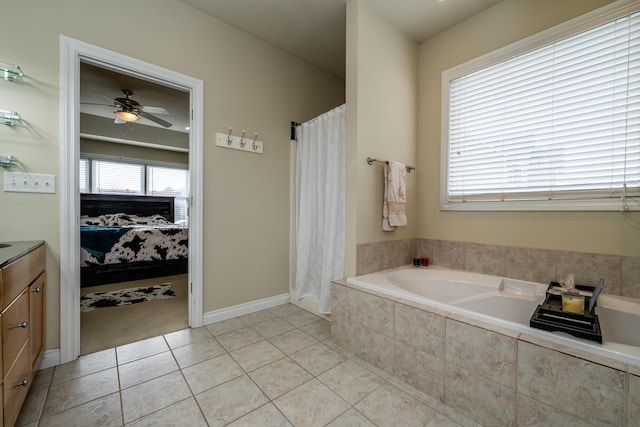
0;245;45;310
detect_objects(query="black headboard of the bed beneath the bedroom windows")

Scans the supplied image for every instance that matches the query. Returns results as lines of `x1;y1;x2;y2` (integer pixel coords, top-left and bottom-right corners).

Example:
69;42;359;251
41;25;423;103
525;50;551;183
80;193;174;222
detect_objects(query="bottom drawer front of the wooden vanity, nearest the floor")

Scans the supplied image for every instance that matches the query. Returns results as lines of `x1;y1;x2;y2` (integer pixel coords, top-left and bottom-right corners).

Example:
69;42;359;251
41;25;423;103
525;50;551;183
2;344;35;426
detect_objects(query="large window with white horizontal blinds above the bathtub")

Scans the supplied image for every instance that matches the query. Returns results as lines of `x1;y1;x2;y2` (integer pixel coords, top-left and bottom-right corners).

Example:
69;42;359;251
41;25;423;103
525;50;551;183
442;7;640;210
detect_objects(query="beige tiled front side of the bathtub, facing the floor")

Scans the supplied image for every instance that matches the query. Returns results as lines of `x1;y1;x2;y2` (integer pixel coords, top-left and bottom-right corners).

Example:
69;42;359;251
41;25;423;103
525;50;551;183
331;281;640;427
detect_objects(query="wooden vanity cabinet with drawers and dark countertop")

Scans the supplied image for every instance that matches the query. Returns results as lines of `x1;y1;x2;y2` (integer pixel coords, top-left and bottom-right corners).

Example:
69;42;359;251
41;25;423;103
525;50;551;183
0;241;46;427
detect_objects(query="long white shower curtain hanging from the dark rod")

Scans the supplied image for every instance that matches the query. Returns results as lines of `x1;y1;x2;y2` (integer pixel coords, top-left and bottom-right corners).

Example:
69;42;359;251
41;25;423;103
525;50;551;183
294;105;346;314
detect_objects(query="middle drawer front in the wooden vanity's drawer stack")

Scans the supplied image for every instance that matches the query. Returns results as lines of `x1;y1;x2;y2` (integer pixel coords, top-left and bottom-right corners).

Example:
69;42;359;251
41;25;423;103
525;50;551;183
2;288;30;378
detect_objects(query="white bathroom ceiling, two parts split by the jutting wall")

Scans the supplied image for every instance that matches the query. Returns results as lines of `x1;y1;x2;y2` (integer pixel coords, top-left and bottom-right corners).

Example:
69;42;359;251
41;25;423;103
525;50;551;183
181;0;501;78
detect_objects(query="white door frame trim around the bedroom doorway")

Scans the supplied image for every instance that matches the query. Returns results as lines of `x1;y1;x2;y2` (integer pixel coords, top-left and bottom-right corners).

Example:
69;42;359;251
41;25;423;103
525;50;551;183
59;35;204;363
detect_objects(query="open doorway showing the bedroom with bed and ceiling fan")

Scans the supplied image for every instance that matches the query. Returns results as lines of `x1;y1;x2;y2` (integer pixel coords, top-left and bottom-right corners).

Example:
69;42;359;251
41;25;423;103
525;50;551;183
79;62;190;355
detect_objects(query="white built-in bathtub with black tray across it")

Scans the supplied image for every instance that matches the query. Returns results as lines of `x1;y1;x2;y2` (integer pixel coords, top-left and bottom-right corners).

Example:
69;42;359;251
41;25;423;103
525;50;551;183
347;266;640;366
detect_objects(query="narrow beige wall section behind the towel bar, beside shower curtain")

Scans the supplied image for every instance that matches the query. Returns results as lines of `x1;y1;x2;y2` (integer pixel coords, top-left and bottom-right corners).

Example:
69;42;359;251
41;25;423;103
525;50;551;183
345;0;419;275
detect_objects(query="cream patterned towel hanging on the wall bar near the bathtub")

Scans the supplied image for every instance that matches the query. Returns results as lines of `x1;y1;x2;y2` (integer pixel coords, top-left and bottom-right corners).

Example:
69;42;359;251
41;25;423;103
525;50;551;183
382;160;407;231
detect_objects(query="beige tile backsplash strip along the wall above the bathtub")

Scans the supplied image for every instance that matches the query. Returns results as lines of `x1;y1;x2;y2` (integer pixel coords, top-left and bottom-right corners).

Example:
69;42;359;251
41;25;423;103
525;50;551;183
356;239;640;298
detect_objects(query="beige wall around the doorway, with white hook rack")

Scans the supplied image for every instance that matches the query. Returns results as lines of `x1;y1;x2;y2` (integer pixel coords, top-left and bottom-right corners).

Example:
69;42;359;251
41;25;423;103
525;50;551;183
0;0;344;349
